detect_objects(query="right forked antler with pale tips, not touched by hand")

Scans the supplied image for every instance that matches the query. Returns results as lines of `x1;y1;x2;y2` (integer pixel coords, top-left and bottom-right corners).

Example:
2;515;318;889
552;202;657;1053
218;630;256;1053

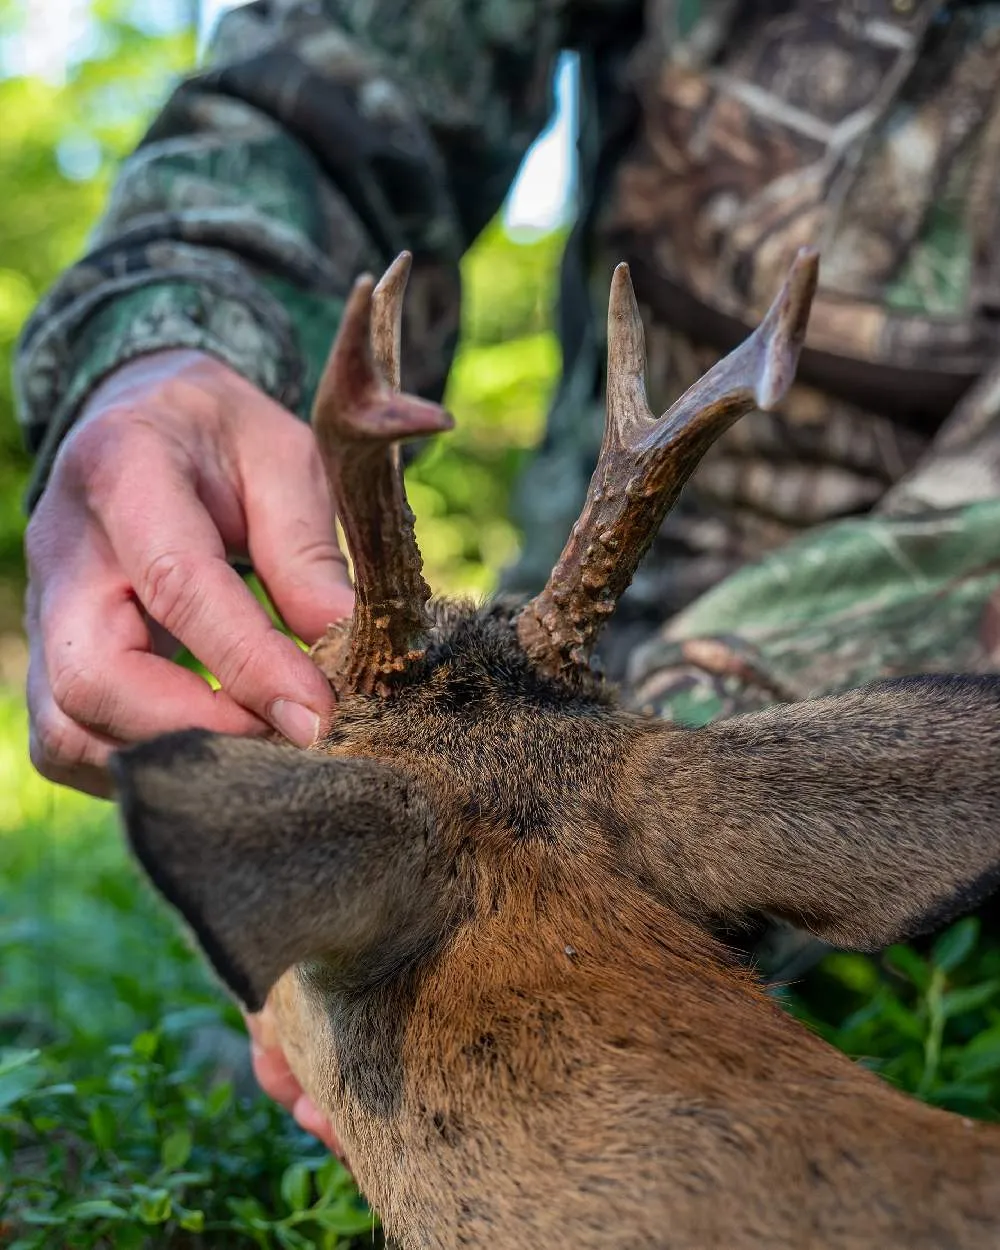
518;248;819;673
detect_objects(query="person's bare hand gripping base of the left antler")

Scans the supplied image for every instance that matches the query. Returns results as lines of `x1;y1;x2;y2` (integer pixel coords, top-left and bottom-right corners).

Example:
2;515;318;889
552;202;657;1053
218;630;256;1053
25;350;353;796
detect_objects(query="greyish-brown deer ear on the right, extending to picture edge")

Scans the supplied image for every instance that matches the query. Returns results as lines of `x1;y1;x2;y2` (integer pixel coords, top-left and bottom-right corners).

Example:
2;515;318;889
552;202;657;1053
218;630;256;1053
636;678;1000;950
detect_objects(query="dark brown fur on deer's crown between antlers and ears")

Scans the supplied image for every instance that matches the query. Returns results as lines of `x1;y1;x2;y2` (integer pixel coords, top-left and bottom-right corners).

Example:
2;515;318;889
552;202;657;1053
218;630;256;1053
321;601;634;841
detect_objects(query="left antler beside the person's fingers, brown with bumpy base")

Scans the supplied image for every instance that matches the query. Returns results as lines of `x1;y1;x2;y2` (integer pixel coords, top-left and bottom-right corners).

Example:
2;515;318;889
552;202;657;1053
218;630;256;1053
313;253;453;694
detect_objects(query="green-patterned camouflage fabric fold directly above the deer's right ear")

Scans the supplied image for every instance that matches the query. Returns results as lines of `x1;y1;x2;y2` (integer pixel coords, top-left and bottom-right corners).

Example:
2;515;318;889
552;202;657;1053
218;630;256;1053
629;365;1000;725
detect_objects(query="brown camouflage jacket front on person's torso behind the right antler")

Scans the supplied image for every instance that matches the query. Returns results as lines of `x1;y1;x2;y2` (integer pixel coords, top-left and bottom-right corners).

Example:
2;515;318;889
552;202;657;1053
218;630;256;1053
509;0;1000;640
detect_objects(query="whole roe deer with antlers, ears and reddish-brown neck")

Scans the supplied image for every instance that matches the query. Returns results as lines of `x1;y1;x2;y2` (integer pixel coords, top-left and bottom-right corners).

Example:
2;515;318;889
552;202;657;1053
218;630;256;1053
109;251;1000;1250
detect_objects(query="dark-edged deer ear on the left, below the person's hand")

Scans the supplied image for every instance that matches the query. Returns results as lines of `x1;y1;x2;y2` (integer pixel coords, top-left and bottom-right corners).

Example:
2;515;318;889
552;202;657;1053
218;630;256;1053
111;730;435;1011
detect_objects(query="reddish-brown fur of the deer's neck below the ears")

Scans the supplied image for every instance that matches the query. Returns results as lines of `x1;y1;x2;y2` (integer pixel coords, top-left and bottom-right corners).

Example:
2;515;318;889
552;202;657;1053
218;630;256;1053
275;844;1000;1250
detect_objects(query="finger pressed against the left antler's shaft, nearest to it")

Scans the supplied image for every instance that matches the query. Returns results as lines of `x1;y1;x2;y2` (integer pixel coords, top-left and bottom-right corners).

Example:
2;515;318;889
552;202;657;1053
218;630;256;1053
240;416;354;643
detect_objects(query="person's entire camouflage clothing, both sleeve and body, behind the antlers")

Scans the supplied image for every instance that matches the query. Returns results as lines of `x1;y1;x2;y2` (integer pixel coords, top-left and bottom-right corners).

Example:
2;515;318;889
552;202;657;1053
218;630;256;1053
18;0;1000;723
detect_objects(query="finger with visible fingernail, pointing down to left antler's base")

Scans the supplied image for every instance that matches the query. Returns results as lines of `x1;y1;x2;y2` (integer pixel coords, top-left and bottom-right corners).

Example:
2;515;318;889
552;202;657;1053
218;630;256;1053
105;460;333;746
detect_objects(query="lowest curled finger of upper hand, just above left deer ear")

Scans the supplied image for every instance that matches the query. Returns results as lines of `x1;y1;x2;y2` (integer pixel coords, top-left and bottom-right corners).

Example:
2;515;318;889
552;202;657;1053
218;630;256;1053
33;534;265;744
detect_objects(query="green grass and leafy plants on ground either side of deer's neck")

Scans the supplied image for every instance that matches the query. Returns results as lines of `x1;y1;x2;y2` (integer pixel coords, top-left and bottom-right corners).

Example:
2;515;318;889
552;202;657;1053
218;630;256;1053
0;665;1000;1250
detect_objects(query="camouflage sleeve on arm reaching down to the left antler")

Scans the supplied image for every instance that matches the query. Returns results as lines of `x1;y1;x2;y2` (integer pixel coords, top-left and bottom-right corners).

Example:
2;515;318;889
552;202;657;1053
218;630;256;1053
15;0;585;505
